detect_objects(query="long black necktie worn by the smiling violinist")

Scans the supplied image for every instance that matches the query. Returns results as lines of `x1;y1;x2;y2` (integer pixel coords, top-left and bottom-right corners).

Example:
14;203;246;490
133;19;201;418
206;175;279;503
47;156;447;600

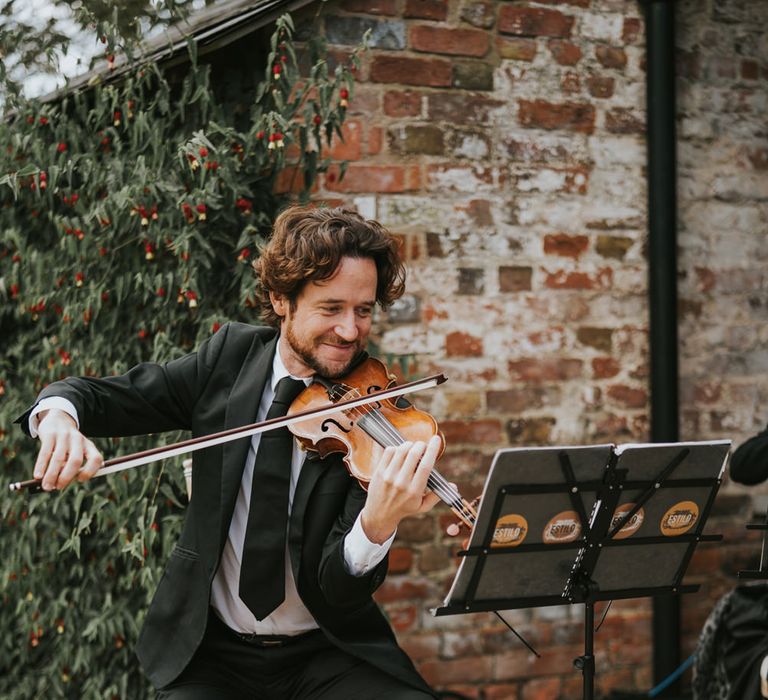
239;377;306;620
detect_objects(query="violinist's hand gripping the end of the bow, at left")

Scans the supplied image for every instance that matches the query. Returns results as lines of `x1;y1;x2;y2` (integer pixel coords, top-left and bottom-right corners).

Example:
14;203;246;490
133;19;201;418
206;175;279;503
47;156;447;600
34;408;104;491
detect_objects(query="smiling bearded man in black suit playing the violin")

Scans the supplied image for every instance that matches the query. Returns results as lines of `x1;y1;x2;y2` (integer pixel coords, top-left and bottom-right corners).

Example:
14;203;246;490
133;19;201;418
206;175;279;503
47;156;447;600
20;207;441;700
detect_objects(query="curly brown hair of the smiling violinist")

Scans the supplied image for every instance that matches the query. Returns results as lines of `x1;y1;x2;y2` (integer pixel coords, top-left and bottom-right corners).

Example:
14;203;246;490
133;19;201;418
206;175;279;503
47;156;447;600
253;206;405;326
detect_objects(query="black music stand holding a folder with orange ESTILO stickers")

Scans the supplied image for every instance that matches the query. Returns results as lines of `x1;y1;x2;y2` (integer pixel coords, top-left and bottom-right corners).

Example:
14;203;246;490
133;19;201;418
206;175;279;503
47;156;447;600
433;441;730;700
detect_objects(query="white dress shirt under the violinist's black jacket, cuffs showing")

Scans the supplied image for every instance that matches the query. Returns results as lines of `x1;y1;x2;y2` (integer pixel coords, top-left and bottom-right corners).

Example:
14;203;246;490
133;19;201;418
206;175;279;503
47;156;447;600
29;337;395;635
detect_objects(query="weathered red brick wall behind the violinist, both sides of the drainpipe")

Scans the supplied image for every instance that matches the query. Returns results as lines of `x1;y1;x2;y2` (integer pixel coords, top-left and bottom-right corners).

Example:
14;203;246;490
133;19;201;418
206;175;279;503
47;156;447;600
302;0;768;700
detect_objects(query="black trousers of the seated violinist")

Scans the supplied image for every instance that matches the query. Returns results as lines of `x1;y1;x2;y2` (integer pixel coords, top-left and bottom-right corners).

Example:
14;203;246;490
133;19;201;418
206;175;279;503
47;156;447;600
157;613;434;700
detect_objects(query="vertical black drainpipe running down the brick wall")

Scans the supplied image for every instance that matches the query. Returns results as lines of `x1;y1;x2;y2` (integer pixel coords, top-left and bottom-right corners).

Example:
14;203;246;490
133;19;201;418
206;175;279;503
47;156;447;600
645;0;680;697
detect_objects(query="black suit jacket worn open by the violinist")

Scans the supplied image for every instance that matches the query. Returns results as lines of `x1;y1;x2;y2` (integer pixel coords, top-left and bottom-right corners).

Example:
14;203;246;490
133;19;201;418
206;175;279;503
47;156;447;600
19;323;436;690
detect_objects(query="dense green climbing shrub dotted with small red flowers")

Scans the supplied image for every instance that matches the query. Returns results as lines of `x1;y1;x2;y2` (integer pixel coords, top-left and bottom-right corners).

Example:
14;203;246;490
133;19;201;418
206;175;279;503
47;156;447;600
0;12;357;700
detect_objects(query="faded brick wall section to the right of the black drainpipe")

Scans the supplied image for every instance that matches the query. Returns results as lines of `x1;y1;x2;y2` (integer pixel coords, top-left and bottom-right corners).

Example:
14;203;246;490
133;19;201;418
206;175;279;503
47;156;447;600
677;0;768;672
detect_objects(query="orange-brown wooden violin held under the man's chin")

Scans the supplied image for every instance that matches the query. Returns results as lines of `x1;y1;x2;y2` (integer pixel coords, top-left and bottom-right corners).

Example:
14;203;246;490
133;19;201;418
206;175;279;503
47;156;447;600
288;357;477;534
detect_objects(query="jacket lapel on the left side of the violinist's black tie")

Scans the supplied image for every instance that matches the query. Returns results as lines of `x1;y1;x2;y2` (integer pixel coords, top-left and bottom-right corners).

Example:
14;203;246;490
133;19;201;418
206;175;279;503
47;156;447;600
220;335;279;542
